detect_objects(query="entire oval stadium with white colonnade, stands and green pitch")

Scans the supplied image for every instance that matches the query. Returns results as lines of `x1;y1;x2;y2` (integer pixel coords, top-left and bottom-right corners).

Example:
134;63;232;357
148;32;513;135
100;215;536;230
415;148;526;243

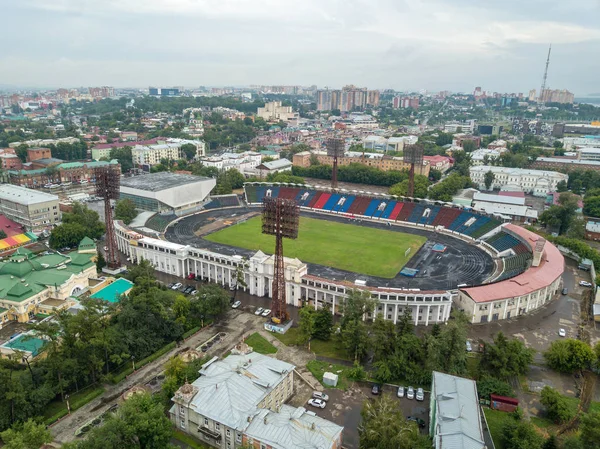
115;183;564;325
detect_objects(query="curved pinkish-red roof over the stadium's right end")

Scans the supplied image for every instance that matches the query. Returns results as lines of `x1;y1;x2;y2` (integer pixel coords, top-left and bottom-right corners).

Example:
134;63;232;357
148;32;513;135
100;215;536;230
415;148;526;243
461;224;565;302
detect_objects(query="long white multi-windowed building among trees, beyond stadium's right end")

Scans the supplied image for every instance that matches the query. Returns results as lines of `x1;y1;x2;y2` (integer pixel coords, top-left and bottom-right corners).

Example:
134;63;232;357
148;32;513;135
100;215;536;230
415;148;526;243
470;165;569;197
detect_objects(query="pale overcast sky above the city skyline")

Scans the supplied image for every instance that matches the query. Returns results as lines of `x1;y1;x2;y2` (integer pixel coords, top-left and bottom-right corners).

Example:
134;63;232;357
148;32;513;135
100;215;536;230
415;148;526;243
0;0;600;96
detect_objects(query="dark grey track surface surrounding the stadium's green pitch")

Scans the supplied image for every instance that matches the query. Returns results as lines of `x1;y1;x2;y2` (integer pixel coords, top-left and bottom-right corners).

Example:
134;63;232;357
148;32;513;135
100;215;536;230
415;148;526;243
165;207;495;290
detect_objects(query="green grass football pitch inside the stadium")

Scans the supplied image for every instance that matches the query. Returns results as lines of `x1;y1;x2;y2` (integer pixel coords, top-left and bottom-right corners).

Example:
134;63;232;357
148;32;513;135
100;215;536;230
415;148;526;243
205;217;427;279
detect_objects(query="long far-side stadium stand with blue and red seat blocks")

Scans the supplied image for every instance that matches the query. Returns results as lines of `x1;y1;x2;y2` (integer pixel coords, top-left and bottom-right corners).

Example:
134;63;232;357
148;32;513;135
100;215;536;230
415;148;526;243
244;183;500;239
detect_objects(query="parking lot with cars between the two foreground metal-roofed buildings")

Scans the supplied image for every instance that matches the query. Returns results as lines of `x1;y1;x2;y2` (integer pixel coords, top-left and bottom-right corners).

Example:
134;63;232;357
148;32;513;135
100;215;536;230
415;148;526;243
293;382;429;449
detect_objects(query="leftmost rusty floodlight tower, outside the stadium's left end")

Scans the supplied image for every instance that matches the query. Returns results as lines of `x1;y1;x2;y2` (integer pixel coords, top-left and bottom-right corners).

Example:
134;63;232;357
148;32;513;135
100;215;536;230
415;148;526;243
94;165;121;268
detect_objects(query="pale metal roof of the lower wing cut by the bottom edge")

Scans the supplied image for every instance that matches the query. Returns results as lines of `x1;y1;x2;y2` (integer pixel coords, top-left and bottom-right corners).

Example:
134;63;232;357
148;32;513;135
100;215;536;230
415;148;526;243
244;405;344;449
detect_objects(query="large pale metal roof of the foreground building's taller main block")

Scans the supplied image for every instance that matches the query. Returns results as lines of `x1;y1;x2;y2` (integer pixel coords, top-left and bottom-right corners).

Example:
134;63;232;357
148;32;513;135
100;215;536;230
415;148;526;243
185;352;295;430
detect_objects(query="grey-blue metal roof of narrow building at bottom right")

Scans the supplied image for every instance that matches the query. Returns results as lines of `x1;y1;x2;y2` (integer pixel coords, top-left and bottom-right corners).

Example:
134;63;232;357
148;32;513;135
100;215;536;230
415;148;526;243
432;371;485;449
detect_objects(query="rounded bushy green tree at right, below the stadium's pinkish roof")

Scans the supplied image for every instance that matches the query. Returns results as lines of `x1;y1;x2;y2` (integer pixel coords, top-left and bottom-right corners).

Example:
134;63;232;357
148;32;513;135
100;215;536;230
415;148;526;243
480;332;535;379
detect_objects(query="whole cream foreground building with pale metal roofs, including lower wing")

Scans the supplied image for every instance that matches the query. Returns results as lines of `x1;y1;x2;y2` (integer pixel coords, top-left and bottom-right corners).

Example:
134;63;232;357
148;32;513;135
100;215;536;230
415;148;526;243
169;350;343;449
